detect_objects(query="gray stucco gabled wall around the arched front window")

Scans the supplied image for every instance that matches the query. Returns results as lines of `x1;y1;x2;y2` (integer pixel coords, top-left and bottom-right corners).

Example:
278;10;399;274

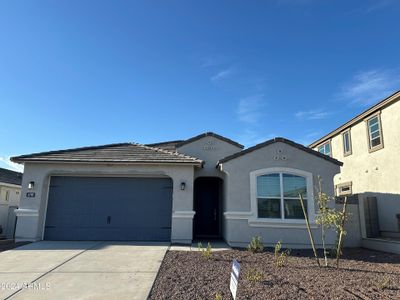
222;142;339;248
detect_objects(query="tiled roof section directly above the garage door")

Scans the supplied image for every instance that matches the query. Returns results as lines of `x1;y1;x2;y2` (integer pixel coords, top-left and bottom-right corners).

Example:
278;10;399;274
11;143;202;165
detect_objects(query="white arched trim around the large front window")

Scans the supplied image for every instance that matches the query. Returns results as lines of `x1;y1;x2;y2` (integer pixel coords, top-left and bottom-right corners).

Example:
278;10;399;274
249;168;315;227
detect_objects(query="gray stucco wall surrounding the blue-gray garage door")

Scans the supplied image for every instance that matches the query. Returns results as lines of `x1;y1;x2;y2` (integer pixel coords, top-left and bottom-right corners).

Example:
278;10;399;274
15;163;194;243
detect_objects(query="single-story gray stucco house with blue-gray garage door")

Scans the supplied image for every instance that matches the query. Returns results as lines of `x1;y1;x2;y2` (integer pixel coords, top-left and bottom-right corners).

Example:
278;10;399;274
12;132;342;248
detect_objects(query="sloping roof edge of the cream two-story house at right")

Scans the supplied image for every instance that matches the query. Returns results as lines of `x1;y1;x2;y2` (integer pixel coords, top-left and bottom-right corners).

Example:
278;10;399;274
308;91;400;148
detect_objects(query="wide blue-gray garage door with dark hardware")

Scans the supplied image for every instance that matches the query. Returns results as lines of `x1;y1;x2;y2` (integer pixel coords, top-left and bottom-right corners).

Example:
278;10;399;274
44;176;172;241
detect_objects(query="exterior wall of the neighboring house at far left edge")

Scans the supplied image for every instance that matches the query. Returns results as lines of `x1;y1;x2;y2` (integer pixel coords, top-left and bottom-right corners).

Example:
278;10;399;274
0;182;21;236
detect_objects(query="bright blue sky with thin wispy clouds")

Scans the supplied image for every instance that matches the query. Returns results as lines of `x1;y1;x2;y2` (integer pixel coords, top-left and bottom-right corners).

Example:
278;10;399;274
0;0;400;168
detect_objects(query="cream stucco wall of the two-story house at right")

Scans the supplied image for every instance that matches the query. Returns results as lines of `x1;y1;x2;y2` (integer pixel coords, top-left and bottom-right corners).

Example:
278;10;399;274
315;101;400;233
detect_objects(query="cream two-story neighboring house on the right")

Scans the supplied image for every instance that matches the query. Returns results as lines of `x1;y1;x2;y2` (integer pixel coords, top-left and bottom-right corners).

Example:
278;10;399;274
309;91;400;244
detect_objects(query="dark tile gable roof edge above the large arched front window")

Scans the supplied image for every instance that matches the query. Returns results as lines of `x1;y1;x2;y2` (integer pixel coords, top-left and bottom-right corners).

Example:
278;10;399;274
217;137;343;166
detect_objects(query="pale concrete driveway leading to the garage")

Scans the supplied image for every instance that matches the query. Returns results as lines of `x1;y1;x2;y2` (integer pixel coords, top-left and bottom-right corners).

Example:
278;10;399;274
0;241;169;300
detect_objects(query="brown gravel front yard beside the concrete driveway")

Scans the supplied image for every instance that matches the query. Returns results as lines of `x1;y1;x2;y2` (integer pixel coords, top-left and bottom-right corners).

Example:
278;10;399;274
149;249;400;299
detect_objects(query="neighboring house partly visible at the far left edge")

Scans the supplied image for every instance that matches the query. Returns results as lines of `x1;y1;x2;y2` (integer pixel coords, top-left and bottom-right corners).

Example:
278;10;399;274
0;168;22;239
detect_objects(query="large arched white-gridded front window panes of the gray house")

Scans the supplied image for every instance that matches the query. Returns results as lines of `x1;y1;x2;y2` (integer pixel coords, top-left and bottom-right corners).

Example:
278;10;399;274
257;173;307;219
